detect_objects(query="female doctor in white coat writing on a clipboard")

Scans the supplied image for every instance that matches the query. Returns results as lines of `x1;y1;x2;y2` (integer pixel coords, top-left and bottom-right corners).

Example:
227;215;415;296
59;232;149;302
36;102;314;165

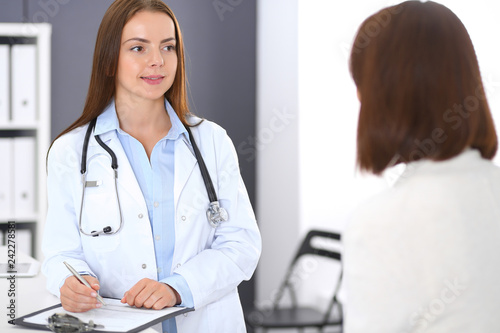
42;0;261;333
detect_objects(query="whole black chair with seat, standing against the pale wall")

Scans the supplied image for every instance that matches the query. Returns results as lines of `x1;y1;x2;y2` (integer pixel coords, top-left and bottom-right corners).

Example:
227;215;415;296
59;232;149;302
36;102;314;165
245;230;342;332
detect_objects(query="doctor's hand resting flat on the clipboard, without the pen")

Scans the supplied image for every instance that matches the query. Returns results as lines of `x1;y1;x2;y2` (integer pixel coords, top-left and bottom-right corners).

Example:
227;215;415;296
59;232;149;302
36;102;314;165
121;278;181;310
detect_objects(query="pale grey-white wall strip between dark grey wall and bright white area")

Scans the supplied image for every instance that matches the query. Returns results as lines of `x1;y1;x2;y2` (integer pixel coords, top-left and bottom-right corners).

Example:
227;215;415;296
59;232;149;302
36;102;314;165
255;0;301;305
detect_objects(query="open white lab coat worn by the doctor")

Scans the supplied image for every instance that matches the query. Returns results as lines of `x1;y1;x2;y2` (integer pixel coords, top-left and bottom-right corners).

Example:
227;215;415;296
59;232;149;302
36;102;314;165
42;114;261;333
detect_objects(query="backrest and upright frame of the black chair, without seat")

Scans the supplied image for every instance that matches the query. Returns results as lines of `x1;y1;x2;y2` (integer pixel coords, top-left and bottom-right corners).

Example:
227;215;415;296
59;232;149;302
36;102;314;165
274;230;342;312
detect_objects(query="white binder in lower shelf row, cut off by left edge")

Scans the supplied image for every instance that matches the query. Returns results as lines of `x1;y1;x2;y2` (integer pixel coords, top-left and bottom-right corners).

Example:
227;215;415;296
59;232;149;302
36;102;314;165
0;138;14;218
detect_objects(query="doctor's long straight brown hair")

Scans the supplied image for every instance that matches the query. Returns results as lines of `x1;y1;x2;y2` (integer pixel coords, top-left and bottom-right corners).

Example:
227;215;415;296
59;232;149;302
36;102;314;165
49;0;190;150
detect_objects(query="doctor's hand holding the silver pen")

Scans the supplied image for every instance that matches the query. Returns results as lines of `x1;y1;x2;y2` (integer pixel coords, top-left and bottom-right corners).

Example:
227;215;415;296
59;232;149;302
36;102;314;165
60;275;102;312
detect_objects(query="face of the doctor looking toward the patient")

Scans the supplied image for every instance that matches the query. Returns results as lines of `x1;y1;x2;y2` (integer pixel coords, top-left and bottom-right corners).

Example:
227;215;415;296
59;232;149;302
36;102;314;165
115;11;177;100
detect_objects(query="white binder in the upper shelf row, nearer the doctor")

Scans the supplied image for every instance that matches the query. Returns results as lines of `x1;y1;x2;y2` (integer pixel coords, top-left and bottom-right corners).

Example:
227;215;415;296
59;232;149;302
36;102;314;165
11;44;37;124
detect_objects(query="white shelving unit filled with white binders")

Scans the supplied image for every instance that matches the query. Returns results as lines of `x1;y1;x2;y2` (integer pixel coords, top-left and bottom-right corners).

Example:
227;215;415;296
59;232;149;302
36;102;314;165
0;23;52;260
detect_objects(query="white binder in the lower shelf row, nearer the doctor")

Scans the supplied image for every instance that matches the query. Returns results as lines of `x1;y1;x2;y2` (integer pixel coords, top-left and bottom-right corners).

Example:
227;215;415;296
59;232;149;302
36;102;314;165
13;137;36;219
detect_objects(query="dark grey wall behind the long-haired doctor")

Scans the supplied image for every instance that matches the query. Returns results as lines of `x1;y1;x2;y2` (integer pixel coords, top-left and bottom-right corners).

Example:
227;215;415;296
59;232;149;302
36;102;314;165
0;0;256;306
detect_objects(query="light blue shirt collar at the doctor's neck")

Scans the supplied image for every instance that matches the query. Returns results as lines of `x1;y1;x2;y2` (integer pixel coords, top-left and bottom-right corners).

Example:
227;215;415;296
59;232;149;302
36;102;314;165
94;99;187;140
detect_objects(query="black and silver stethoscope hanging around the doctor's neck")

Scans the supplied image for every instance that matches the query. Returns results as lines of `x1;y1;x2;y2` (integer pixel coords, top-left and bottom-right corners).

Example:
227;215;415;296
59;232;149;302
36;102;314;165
78;118;229;237
